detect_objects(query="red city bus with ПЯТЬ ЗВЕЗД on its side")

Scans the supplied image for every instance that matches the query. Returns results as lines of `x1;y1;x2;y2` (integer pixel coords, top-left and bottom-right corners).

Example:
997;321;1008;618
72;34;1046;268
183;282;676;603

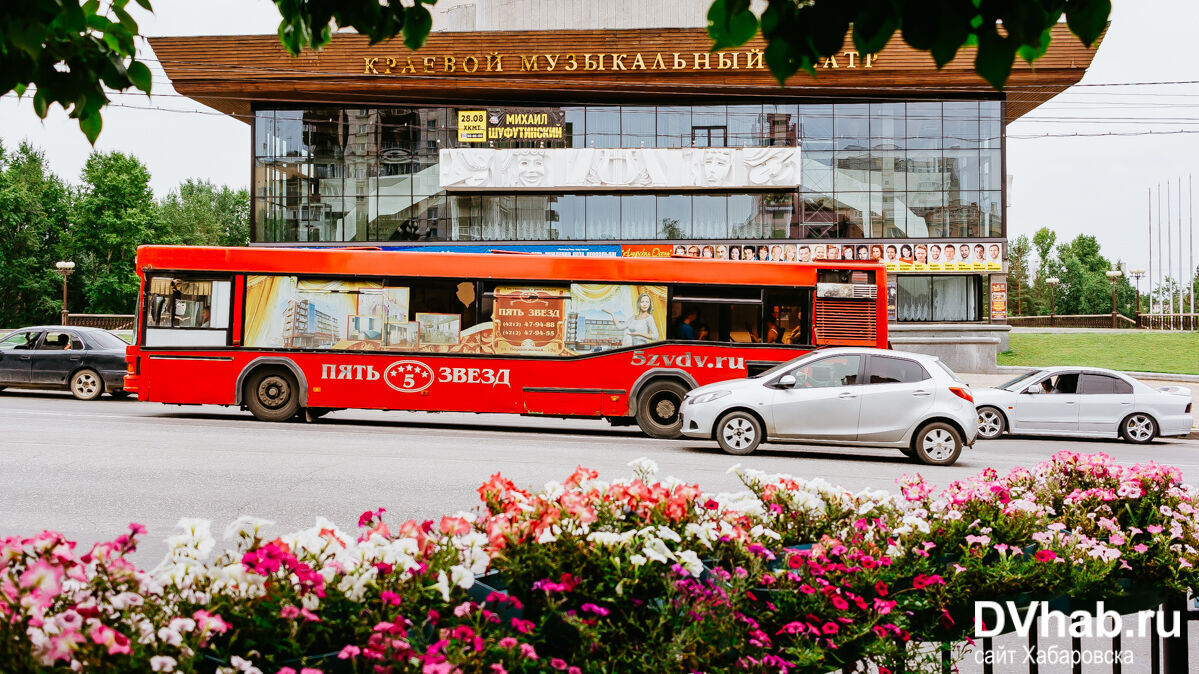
125;246;887;438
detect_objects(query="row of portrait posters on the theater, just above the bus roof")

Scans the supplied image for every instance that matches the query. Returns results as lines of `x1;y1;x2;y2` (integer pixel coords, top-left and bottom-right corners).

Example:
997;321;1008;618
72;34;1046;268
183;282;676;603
621;240;1004;271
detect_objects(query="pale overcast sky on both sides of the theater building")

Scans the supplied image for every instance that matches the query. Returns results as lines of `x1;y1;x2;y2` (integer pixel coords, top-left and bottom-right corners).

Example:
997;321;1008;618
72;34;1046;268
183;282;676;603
0;0;1199;284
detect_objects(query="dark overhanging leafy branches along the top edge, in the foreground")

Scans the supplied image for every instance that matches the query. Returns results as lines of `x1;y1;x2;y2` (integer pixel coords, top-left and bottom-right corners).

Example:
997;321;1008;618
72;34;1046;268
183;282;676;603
0;0;1111;143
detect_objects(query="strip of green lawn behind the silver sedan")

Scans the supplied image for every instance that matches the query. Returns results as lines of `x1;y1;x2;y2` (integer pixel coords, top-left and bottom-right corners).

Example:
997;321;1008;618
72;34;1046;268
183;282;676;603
999;330;1199;374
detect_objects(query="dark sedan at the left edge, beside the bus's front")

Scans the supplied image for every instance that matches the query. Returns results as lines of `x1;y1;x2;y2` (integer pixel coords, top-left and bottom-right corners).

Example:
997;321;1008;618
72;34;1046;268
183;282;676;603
0;325;128;401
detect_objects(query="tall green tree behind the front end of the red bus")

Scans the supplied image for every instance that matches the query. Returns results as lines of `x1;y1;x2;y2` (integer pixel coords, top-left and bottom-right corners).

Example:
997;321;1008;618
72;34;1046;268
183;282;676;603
68;151;169;313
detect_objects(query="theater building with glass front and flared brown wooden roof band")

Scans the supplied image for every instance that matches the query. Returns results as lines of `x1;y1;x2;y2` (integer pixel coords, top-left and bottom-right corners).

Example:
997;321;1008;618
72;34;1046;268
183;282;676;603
150;0;1093;364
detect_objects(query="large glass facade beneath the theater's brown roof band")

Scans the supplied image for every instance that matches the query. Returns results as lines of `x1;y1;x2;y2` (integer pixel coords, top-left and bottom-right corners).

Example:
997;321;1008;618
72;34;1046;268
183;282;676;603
254;101;1005;242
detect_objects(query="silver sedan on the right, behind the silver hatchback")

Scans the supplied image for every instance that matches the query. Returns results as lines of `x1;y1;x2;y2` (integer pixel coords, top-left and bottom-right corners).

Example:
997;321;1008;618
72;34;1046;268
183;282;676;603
974;367;1193;444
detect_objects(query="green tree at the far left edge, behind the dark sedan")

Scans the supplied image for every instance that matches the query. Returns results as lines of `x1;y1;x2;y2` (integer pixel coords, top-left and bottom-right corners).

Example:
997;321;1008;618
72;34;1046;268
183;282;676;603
0;143;71;327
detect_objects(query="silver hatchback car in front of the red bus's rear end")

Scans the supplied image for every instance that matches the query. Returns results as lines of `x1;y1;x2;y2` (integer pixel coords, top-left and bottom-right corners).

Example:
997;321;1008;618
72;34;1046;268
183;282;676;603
680;348;978;465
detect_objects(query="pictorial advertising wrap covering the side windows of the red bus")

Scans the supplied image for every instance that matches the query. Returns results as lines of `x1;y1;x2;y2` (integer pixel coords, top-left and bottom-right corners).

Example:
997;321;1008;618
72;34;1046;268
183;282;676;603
238;276;667;355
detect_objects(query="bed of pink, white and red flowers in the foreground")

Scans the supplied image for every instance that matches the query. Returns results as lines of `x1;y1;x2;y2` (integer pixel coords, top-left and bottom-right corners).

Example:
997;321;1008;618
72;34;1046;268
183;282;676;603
0;452;1199;674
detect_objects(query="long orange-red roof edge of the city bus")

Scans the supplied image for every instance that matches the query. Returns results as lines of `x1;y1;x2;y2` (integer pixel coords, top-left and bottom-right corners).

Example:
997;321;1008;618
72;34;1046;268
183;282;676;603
137;246;884;285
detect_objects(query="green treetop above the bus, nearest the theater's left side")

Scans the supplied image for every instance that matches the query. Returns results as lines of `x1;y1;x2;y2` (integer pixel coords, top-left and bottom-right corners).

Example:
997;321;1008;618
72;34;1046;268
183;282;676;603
158;180;249;246
